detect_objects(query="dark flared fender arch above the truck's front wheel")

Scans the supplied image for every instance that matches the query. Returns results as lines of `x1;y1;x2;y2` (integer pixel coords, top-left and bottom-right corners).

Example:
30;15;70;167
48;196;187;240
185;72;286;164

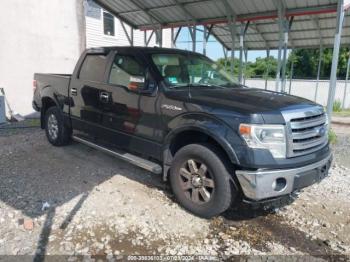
164;113;241;165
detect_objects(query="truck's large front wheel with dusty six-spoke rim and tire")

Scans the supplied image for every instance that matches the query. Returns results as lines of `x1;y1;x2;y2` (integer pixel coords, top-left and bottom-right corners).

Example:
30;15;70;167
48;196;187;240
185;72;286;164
170;144;237;218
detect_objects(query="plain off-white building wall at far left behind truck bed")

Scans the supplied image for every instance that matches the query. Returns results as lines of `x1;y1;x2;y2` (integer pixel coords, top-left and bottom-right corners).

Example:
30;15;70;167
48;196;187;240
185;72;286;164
0;0;85;115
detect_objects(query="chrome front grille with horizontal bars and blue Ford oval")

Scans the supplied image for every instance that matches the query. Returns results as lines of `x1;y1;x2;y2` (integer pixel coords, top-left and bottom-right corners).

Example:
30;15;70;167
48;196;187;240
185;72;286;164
282;106;328;157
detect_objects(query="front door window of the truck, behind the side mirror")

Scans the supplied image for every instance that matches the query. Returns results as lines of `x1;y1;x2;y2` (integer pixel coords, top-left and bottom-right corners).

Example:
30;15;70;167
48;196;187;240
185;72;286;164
108;55;147;91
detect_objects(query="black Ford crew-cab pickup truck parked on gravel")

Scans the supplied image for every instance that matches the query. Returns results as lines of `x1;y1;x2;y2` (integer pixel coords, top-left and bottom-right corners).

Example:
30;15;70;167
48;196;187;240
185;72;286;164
33;47;332;218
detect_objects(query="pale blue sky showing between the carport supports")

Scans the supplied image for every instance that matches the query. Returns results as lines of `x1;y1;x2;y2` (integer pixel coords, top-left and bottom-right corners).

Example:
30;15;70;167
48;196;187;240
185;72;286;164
176;27;277;62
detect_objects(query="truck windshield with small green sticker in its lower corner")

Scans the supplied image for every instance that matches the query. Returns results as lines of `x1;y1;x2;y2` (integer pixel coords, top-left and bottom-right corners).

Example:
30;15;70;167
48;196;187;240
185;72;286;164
152;54;239;89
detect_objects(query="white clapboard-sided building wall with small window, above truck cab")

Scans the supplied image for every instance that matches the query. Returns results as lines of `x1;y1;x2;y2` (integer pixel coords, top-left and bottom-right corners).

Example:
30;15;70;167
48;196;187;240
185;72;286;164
85;1;171;48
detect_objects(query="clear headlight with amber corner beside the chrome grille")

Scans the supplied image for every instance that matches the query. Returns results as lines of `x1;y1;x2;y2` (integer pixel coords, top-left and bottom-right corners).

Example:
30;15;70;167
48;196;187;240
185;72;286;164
239;124;286;158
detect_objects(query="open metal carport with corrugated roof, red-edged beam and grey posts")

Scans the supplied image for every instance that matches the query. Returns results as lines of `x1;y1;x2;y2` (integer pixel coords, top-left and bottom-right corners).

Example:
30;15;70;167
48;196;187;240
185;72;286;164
95;0;350;122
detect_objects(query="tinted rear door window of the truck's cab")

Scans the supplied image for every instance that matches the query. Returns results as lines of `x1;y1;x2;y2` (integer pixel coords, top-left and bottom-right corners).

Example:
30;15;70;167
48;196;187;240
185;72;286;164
79;55;107;82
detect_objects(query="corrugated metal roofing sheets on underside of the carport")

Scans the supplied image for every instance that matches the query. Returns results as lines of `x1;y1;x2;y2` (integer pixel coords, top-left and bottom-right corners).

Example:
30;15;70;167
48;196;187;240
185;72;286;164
95;0;350;49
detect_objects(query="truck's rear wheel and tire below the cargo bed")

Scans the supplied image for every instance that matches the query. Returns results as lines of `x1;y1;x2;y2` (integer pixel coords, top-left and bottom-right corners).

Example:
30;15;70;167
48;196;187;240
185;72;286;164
45;107;72;146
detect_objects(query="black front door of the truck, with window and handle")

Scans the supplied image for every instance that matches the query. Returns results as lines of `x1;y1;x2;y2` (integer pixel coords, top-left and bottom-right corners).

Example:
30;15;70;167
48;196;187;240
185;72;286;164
100;51;162;159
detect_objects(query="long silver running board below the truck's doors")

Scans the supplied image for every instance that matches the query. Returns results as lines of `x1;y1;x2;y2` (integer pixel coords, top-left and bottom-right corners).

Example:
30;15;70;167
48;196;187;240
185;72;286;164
72;136;162;174
